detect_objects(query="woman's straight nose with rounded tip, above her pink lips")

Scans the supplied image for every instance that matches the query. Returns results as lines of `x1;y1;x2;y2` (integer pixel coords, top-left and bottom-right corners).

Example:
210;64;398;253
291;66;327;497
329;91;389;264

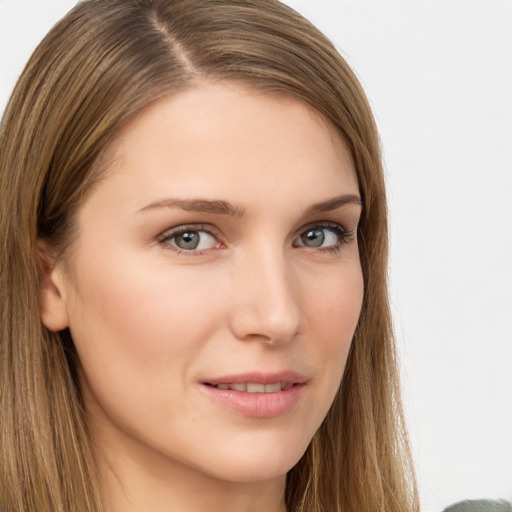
230;247;304;345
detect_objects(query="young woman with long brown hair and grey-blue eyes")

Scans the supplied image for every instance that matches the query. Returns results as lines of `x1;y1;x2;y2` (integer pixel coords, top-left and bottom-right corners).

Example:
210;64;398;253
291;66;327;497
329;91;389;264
0;0;418;512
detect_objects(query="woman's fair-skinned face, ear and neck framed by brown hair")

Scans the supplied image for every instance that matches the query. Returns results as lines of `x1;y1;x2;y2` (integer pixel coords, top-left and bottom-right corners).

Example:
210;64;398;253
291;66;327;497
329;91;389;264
43;83;363;512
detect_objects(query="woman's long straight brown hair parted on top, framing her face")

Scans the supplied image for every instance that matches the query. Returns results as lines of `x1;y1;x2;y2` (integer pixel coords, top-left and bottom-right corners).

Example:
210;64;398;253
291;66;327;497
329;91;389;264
0;0;418;512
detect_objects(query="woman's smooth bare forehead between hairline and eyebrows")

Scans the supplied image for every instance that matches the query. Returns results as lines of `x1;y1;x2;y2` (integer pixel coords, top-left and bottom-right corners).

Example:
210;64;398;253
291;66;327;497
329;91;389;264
84;82;358;216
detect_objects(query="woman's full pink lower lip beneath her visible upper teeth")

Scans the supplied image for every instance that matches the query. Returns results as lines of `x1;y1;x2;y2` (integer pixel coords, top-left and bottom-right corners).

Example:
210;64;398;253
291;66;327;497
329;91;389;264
201;384;305;419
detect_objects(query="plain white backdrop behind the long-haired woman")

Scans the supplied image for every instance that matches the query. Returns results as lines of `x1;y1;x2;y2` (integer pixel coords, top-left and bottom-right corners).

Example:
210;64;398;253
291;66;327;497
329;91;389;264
0;0;512;512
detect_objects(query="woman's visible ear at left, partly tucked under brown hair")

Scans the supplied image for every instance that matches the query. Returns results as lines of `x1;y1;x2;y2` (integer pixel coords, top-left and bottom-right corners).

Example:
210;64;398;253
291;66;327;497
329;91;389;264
37;240;69;332
